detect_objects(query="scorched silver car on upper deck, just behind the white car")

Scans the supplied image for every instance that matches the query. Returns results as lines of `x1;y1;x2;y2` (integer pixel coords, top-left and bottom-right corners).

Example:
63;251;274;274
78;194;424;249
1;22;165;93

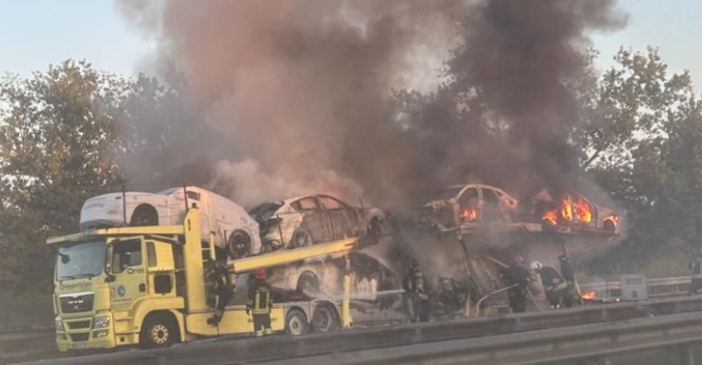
249;194;385;252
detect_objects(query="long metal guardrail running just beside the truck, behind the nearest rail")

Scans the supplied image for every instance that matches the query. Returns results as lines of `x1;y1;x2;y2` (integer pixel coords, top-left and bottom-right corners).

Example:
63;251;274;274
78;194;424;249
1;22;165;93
15;296;702;365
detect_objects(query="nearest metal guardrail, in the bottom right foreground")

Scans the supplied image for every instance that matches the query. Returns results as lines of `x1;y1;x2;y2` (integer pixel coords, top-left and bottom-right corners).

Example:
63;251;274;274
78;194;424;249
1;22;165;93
264;312;702;365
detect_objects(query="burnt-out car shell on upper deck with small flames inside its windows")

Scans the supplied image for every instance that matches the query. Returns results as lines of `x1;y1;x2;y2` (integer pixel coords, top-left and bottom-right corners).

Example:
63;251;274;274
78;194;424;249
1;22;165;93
420;184;519;229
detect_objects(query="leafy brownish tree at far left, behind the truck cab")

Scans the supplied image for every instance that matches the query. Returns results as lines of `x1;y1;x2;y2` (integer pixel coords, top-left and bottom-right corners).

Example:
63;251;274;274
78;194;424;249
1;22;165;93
0;60;130;287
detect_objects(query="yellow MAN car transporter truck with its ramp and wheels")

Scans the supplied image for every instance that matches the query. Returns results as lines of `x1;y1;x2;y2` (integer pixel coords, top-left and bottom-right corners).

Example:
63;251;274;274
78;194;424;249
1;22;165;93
47;208;357;351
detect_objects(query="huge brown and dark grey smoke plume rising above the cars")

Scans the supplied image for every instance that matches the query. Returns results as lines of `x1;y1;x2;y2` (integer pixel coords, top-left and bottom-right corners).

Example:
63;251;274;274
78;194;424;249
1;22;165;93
118;0;625;205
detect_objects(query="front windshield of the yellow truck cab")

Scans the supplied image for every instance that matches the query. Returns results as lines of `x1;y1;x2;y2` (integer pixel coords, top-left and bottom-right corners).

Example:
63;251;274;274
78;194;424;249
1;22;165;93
56;241;107;280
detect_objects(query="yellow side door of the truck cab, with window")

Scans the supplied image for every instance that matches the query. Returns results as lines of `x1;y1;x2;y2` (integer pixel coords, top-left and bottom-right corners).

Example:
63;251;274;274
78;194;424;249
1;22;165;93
108;237;147;309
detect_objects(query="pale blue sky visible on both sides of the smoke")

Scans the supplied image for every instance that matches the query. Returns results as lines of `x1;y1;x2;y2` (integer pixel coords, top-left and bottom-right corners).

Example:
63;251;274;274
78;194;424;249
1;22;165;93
0;0;702;90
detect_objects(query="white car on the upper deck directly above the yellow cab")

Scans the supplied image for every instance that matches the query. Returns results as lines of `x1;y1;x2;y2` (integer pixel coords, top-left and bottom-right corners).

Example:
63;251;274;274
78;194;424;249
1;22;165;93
80;186;261;258
